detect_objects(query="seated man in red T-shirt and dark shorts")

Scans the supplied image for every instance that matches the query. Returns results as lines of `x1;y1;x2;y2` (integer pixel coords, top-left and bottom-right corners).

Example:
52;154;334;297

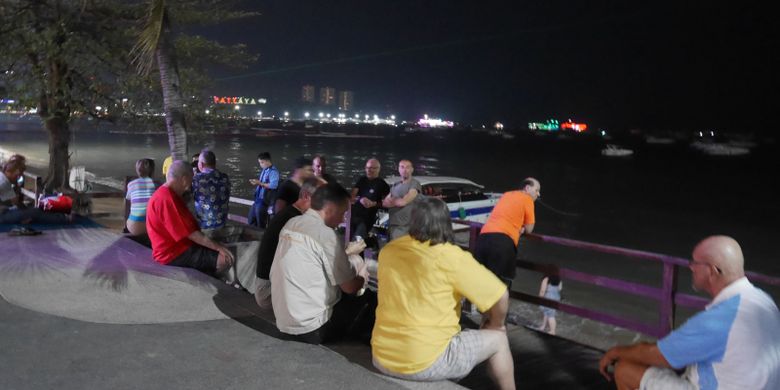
146;160;234;275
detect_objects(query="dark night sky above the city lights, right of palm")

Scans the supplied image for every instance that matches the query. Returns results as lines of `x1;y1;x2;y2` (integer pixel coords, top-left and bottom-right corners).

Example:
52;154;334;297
202;0;780;131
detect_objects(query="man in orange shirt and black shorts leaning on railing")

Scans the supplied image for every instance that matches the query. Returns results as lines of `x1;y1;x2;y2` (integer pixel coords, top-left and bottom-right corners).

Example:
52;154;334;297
475;177;542;287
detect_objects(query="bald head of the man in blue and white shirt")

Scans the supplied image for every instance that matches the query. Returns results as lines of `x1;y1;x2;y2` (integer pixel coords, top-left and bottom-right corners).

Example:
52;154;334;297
693;236;745;283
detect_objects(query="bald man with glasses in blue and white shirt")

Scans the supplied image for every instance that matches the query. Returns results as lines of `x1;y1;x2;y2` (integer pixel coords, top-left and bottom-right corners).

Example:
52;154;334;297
599;236;780;390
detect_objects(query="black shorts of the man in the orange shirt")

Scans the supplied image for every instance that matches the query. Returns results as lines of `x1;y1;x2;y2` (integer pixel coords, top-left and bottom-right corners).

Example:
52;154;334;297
474;233;517;285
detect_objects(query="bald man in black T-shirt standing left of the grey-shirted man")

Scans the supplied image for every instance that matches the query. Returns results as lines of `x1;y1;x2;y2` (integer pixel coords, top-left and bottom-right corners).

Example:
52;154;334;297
350;158;390;244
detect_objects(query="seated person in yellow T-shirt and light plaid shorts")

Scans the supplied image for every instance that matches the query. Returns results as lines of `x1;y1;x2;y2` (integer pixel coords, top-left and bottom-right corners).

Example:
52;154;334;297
371;198;515;389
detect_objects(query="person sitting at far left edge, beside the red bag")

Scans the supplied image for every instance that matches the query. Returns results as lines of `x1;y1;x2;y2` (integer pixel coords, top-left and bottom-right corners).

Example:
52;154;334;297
0;154;73;224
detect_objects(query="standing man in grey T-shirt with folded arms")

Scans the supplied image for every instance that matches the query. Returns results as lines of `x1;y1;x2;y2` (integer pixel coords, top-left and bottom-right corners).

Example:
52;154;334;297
382;160;422;240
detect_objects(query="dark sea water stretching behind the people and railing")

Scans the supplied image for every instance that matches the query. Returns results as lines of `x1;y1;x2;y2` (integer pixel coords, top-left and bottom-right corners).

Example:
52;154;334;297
0;117;780;340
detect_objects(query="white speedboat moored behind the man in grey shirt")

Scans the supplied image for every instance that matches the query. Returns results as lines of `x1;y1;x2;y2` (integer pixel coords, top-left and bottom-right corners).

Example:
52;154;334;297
374;176;502;228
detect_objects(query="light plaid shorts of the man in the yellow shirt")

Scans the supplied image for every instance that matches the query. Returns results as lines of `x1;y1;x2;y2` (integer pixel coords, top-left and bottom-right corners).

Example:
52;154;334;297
373;329;490;382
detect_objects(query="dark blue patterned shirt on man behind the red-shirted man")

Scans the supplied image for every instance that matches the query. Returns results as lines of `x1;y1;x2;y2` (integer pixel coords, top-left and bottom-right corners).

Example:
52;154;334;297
192;169;230;229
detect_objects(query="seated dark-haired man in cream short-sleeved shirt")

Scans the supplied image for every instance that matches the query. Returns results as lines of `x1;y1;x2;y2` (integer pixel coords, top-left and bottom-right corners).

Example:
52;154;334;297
271;183;376;344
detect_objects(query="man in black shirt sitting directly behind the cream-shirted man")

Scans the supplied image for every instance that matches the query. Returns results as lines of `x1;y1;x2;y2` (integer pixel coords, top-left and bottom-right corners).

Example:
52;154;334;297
255;177;320;309
